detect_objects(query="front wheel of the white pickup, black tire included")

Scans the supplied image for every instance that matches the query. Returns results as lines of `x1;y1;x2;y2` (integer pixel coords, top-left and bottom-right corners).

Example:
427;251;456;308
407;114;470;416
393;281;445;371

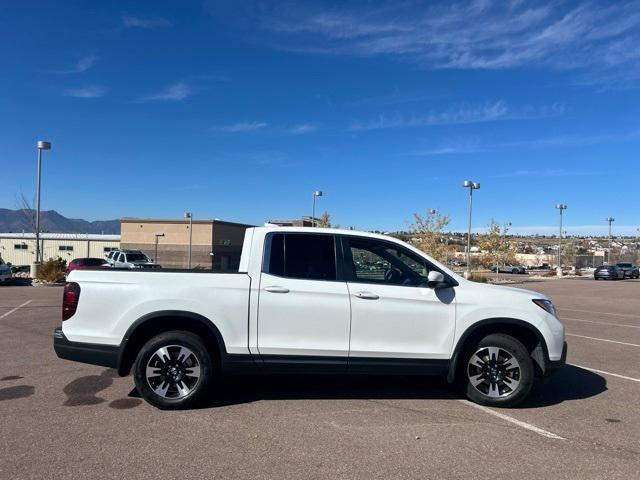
459;333;535;407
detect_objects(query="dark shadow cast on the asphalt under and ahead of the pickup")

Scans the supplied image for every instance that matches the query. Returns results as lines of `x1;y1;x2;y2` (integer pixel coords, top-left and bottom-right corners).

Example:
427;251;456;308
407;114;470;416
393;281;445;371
203;365;607;408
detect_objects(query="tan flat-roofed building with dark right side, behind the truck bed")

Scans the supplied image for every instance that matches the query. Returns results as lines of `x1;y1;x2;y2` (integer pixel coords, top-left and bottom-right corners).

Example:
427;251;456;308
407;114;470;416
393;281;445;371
120;218;253;271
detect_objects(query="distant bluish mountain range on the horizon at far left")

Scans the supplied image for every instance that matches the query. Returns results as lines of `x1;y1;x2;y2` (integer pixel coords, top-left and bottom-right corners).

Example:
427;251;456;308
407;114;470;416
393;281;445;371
0;208;120;235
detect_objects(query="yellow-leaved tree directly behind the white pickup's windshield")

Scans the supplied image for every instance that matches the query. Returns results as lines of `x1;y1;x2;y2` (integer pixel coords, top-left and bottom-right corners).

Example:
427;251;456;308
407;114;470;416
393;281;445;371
408;210;454;262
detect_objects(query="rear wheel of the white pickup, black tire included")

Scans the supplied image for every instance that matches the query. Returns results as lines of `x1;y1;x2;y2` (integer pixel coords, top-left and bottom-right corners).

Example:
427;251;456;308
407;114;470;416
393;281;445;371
133;330;217;410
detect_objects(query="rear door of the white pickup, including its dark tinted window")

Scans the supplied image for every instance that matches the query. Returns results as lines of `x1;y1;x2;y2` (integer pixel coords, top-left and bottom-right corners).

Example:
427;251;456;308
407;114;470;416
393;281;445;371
258;232;350;369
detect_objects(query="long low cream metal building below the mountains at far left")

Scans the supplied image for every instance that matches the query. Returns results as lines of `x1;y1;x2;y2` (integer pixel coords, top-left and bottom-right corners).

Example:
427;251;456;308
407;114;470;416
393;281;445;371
0;233;120;266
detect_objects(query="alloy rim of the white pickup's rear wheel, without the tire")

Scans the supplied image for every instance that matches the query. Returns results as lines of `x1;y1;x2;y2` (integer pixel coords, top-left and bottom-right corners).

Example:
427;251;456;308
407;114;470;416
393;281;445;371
146;345;201;399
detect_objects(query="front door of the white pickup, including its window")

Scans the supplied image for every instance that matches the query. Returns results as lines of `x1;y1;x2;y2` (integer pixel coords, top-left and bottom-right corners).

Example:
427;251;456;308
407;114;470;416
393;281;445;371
342;235;455;364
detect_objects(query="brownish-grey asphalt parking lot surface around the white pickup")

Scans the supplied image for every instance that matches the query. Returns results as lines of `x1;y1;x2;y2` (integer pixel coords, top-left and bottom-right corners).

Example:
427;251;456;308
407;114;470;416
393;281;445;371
0;278;640;479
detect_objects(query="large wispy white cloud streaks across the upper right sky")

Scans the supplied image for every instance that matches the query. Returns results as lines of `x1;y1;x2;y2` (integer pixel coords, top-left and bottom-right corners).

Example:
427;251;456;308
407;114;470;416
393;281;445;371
244;0;640;85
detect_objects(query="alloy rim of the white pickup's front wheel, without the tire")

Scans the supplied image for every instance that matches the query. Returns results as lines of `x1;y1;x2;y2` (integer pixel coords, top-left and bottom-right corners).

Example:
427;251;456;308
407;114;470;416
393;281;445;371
467;347;521;398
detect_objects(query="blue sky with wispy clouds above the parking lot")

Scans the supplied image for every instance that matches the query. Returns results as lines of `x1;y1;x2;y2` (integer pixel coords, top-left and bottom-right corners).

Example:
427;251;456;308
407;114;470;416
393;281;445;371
0;0;640;234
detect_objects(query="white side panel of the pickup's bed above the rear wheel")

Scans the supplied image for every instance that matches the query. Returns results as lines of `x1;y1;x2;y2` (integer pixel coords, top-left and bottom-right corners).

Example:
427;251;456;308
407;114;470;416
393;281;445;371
63;269;251;353
